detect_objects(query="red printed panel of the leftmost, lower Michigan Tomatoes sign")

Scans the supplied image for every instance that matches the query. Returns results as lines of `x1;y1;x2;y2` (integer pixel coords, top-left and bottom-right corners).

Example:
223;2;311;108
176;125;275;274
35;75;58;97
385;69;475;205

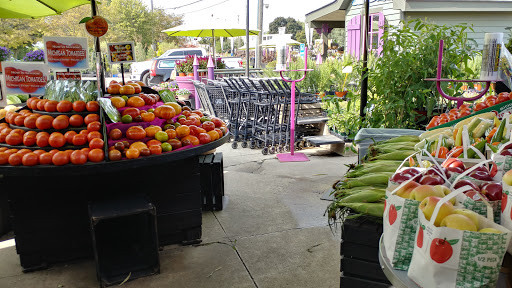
4;67;48;93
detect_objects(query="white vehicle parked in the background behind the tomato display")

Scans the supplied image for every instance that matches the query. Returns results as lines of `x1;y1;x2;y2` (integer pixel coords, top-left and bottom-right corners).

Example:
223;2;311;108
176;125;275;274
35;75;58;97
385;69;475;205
130;48;206;85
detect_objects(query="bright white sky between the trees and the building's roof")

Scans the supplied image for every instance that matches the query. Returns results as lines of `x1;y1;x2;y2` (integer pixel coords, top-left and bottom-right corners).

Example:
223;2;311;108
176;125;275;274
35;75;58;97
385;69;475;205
142;0;334;31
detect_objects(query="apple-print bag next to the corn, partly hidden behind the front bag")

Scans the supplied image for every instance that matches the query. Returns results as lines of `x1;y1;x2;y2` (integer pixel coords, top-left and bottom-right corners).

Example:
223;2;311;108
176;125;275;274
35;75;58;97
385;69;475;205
383;152;446;270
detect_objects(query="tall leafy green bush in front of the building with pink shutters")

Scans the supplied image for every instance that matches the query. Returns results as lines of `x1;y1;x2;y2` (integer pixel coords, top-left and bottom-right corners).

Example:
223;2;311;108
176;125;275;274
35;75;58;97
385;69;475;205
364;19;478;129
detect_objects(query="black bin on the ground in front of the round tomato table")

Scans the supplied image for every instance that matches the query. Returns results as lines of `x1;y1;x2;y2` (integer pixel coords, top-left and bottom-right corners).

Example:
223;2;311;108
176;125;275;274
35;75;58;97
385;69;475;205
89;195;160;287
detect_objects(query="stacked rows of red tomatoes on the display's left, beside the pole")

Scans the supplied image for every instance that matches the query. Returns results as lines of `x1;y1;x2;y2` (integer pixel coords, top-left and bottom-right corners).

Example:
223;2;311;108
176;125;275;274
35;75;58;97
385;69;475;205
0;97;105;166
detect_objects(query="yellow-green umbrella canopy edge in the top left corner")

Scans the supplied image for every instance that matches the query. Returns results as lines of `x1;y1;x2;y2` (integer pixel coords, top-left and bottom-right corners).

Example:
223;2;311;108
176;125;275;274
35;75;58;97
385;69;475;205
0;0;91;18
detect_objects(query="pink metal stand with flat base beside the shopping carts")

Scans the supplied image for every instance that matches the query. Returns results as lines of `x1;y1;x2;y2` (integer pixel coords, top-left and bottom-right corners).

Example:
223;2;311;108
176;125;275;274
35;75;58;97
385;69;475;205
277;47;312;162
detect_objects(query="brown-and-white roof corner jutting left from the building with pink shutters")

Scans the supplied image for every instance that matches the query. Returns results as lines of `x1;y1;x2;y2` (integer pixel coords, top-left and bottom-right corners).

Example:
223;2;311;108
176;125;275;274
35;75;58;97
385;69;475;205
306;0;351;28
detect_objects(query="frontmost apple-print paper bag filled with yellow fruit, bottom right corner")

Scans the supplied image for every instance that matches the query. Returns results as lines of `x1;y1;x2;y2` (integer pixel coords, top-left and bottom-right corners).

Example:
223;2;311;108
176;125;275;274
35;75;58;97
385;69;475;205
407;186;512;288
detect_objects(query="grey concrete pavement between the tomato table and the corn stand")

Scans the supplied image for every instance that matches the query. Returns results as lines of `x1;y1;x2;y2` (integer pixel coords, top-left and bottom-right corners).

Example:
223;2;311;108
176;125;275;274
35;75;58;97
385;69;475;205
0;143;357;288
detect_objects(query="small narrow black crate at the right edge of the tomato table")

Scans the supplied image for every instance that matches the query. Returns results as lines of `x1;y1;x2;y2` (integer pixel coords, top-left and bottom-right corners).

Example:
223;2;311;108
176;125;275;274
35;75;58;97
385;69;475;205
199;152;224;211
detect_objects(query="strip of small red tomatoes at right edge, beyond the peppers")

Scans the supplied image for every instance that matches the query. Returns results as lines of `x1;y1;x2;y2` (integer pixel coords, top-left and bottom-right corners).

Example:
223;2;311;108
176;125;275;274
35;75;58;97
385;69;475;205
426;92;512;130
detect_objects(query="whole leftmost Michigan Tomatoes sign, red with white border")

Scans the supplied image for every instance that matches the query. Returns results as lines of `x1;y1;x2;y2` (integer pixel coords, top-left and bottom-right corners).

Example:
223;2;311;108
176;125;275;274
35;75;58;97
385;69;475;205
2;62;50;95
